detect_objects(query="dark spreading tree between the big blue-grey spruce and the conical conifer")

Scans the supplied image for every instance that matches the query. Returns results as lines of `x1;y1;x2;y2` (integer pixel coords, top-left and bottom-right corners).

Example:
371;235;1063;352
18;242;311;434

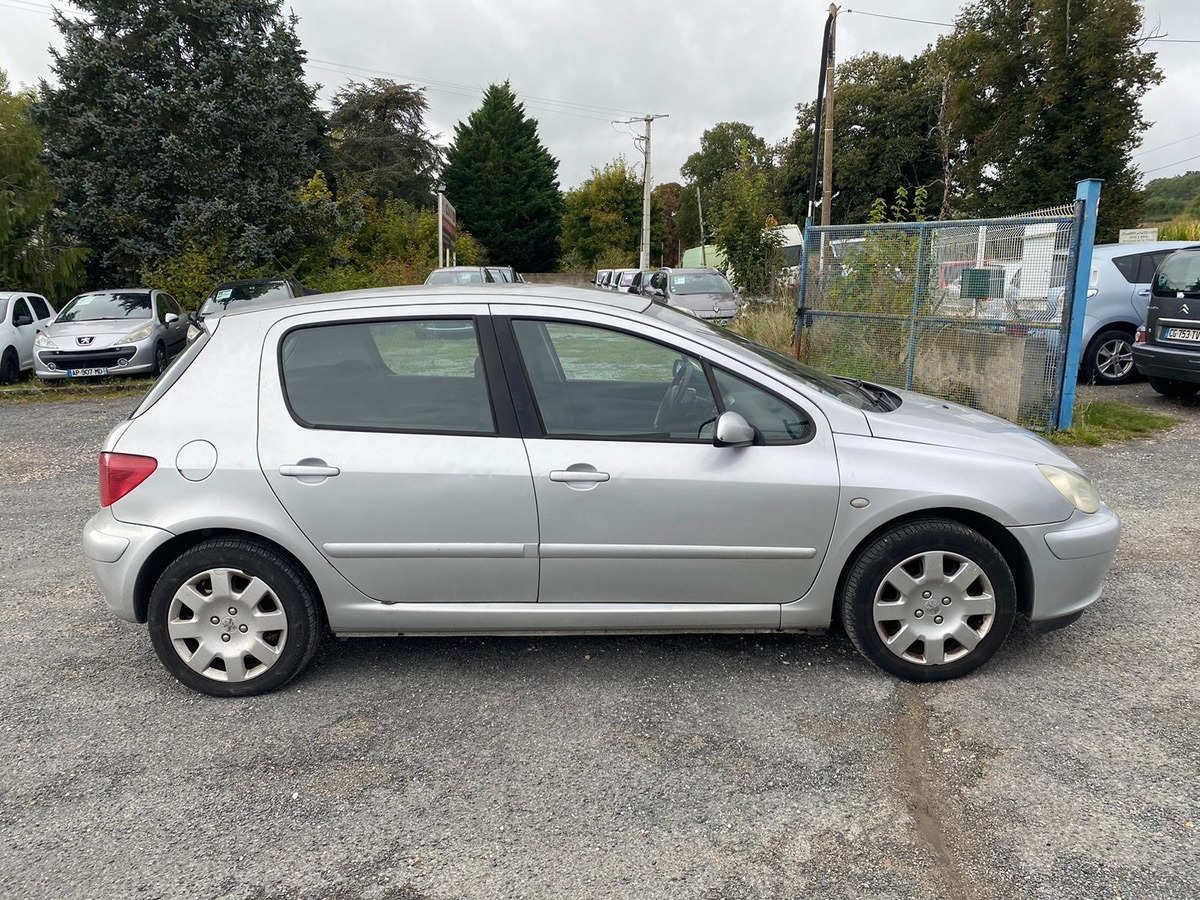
329;78;442;206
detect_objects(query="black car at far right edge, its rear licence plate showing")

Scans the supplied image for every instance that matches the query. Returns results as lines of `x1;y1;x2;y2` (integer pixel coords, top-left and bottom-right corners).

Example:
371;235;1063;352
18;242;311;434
1133;247;1200;397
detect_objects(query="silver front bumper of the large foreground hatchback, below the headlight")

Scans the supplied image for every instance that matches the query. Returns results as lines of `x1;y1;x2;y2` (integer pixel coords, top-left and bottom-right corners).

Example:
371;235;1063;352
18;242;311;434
1008;505;1121;625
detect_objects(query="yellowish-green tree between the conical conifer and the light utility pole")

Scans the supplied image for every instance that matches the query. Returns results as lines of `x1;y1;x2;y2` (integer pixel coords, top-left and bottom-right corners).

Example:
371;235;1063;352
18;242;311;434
562;157;642;271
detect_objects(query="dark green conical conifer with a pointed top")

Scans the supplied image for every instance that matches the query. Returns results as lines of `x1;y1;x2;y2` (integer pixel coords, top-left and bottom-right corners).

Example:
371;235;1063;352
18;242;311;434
443;82;564;272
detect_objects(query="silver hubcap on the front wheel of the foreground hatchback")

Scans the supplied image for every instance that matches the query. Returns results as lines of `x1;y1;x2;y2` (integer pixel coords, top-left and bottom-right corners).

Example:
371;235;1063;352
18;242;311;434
872;550;996;666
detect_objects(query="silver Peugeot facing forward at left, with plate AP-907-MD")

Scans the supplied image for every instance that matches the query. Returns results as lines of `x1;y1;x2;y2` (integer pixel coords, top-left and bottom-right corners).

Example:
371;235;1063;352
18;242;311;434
34;288;187;380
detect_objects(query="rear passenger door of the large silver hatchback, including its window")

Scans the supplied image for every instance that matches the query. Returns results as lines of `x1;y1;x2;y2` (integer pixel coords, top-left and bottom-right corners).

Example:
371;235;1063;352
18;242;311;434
258;305;538;602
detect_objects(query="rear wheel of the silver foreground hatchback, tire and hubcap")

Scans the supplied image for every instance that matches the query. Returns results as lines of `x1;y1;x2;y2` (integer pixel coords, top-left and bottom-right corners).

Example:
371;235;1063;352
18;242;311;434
148;538;320;697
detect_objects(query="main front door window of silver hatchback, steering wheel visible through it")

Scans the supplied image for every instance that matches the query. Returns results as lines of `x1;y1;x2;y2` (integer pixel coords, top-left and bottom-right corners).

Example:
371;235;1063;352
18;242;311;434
512;320;716;442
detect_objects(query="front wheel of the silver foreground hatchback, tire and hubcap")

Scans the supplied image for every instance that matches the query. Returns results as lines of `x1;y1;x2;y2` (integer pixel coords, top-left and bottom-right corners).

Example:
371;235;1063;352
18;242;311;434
840;518;1016;682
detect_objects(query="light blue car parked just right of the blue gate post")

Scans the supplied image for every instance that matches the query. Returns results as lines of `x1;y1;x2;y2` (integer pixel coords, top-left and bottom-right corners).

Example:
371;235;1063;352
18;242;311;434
1075;241;1200;384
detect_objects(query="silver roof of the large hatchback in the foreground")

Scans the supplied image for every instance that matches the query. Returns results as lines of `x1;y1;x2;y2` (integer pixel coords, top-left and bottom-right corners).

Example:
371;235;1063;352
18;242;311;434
214;286;650;319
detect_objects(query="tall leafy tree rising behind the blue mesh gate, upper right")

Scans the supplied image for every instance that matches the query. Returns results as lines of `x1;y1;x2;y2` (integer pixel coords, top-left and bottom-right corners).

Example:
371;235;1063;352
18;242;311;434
936;0;1163;240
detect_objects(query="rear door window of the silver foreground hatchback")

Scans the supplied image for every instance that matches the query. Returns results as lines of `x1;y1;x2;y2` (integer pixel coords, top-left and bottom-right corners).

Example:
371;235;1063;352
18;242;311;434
280;317;496;434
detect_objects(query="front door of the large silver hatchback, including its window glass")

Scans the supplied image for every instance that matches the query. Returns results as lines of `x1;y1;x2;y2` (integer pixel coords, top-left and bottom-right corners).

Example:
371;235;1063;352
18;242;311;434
493;305;839;604
